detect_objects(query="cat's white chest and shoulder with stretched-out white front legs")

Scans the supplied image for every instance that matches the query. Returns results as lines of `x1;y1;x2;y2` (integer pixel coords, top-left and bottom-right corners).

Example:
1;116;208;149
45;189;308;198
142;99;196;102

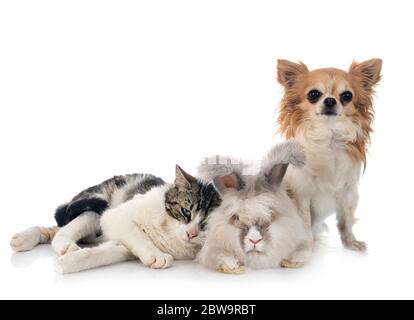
55;184;200;273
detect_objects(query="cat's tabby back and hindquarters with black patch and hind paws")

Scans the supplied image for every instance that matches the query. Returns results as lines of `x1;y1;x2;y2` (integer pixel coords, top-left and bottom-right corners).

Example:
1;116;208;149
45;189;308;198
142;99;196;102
10;174;165;255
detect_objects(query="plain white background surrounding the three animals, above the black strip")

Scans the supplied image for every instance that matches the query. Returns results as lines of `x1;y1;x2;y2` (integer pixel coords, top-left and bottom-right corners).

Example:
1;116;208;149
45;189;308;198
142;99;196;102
0;0;414;299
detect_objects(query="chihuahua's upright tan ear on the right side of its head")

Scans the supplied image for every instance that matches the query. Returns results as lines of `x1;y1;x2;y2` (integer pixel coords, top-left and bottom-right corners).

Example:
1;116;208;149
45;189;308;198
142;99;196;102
349;59;382;90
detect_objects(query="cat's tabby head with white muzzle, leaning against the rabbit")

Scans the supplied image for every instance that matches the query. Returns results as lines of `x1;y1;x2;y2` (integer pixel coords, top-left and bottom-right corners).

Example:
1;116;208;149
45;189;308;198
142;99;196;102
165;165;221;244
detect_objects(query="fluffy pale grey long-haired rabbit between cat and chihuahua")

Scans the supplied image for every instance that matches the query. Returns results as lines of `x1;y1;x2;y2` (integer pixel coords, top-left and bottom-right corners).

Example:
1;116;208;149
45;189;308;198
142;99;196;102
197;141;307;274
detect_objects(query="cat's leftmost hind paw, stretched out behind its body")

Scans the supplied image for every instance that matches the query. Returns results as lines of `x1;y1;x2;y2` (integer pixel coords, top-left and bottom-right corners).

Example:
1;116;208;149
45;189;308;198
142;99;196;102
10;227;59;252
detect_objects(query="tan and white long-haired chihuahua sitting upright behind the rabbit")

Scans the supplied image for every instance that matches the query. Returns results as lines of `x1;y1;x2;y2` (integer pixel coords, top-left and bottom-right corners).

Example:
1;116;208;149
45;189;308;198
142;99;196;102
277;59;382;262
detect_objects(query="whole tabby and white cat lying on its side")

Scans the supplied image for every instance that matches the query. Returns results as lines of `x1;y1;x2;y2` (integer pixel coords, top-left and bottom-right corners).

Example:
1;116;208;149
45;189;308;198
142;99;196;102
11;166;221;273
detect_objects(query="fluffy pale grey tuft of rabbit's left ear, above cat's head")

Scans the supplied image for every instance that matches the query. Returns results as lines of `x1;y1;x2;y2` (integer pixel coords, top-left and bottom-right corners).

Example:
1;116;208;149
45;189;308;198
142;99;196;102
197;155;247;181
